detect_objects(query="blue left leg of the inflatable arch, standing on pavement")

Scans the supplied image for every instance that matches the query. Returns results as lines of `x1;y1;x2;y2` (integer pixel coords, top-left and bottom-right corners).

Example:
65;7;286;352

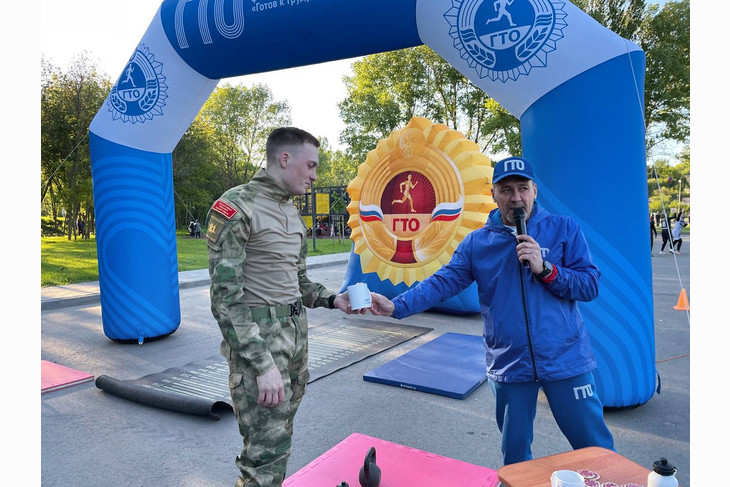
90;137;180;343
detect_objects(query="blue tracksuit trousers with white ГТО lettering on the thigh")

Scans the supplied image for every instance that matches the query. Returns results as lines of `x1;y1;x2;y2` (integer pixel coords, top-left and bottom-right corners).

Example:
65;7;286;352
489;372;614;465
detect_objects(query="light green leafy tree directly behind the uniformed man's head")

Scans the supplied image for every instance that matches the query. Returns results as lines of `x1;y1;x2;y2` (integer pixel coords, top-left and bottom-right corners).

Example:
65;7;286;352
198;83;291;188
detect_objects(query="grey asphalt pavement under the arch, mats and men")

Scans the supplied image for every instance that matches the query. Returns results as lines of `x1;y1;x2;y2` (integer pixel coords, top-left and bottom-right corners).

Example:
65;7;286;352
39;236;691;487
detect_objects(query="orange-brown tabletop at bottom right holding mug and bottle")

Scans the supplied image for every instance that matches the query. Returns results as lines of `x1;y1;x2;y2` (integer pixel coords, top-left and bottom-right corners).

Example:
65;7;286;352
497;446;650;487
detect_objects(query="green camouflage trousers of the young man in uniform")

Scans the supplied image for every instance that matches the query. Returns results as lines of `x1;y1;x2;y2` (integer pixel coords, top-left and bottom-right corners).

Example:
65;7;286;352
221;310;309;487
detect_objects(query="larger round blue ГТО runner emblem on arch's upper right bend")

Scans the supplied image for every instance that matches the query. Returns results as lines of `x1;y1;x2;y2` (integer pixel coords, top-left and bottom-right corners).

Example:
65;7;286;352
444;0;567;81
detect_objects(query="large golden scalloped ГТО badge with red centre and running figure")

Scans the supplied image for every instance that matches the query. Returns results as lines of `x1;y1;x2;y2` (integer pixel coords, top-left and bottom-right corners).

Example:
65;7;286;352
347;117;496;286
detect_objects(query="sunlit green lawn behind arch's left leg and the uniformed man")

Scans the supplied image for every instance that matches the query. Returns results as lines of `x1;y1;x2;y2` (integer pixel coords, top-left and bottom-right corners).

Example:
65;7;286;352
41;231;352;287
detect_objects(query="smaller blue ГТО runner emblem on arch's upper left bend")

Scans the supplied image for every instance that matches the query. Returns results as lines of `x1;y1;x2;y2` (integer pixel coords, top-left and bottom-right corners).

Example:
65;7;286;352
107;44;167;123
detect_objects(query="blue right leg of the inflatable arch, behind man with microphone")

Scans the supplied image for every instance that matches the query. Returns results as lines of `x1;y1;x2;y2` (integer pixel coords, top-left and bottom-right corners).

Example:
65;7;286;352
521;51;656;407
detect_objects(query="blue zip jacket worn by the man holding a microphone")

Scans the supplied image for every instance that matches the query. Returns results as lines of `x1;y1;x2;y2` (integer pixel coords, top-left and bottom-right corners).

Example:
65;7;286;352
392;203;600;382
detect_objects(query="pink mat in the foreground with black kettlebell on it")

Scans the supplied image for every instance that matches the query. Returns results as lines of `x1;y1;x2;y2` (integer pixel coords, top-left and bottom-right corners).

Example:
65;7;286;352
283;433;499;487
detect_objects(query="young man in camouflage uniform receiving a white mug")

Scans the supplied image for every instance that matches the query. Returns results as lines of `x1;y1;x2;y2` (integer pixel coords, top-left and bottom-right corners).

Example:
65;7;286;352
206;127;365;487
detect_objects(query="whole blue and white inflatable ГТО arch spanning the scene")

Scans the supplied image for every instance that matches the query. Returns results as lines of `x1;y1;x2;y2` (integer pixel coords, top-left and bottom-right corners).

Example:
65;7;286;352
89;0;656;407
